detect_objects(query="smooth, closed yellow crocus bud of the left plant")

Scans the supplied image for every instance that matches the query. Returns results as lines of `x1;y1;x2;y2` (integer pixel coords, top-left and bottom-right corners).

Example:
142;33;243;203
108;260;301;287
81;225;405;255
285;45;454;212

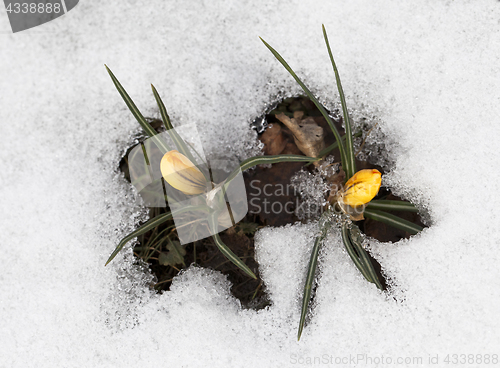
160;150;207;195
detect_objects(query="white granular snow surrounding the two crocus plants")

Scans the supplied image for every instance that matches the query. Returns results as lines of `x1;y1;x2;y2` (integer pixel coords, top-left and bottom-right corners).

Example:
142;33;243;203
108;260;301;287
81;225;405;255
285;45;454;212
0;0;500;367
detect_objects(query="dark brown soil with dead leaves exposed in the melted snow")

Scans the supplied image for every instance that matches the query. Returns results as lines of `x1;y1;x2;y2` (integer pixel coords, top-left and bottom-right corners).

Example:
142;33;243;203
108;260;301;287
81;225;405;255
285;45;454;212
120;96;424;309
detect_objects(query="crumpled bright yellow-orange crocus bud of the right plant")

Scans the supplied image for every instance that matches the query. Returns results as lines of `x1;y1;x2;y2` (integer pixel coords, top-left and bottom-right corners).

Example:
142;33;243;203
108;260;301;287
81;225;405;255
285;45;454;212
341;169;382;207
